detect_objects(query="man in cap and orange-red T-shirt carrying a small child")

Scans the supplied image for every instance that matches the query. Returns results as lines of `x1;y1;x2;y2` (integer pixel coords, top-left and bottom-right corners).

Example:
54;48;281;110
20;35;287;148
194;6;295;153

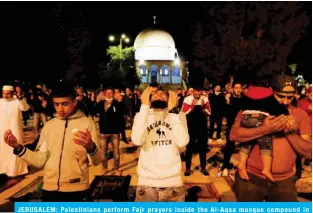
230;75;312;202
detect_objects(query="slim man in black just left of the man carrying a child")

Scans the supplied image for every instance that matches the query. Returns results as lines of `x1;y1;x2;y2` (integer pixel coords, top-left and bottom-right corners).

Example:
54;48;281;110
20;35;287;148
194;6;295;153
221;82;243;177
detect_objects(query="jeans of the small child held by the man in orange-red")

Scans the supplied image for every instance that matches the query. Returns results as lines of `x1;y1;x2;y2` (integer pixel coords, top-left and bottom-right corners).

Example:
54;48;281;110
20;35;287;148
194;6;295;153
240;114;273;156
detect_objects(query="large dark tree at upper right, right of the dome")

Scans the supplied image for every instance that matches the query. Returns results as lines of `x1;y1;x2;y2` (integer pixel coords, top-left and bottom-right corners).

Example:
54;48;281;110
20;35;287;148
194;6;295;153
193;2;309;85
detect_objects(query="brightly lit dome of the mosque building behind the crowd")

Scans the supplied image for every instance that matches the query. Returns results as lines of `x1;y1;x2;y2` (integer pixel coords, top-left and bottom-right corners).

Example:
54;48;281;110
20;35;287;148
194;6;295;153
134;28;177;60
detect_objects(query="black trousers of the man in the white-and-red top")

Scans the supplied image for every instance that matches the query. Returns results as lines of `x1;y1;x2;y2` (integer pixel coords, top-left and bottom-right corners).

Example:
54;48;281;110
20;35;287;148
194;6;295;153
185;131;208;170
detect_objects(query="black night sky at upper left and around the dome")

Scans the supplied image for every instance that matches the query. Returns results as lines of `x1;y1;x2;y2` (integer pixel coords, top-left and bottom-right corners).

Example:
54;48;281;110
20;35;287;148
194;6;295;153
0;2;312;84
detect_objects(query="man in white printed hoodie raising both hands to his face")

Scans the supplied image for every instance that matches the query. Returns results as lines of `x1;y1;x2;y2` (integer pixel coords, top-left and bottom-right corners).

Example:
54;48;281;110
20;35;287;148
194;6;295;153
131;87;189;202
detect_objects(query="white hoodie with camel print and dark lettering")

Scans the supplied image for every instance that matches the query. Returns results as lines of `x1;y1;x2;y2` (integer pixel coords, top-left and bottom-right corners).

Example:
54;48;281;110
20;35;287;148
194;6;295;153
131;104;189;187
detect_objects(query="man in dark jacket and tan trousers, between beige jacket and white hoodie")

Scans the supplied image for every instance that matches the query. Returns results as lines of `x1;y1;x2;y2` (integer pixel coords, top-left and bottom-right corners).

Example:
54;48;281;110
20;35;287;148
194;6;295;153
96;88;124;175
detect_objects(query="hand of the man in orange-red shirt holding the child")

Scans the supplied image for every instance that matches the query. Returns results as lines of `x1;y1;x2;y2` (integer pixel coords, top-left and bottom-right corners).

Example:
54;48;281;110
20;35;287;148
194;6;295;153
263;115;288;135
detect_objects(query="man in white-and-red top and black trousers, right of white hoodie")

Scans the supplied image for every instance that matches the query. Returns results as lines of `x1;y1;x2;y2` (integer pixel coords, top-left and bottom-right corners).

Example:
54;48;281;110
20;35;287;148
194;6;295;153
182;87;211;176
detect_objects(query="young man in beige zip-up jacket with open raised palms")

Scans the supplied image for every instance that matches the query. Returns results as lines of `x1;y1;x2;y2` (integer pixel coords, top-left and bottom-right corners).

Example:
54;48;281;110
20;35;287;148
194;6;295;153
4;83;101;202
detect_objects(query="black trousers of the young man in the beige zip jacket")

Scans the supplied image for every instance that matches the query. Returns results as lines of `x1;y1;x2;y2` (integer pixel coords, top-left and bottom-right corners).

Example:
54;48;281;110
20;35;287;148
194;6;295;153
41;189;90;202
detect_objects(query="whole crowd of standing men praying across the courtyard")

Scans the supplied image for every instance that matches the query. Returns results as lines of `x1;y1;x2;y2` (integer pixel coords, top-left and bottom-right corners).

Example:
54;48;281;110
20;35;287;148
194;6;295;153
0;75;312;201
